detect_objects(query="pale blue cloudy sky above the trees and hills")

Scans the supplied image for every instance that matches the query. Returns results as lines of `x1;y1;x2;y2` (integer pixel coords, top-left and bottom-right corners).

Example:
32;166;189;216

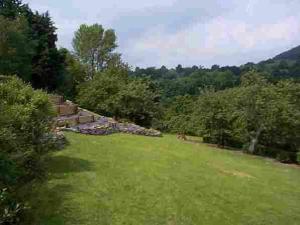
23;0;300;67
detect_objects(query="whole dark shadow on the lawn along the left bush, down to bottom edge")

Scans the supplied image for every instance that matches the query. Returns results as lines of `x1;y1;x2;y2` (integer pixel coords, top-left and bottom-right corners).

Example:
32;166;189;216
22;156;93;225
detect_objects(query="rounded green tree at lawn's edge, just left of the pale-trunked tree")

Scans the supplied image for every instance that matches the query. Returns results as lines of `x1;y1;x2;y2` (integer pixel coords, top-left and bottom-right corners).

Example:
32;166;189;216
193;89;241;147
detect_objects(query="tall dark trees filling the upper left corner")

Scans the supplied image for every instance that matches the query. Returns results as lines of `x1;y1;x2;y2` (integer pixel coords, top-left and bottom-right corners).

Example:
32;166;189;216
0;0;64;91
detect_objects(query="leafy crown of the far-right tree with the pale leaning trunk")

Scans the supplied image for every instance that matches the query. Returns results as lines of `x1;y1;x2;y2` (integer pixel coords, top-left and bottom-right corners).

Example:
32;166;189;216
239;77;300;156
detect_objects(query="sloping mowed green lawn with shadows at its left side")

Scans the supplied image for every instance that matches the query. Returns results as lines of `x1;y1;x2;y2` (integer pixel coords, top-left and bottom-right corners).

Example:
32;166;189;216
30;133;300;225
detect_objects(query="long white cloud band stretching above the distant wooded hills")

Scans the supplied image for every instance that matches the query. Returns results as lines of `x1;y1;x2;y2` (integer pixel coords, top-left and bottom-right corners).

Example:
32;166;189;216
124;17;300;66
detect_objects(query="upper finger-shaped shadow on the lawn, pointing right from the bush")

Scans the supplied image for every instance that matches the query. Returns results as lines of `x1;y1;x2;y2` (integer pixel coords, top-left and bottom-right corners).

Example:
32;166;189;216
47;156;93;175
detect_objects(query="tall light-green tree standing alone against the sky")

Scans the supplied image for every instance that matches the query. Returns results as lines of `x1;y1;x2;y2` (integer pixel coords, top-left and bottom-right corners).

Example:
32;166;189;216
73;24;118;79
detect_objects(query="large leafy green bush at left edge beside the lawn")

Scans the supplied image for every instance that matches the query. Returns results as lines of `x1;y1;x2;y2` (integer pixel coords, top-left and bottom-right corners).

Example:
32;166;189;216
0;77;54;224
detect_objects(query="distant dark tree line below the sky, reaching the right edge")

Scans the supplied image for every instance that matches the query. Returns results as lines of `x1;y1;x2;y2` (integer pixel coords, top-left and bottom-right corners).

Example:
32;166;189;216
131;59;300;100
